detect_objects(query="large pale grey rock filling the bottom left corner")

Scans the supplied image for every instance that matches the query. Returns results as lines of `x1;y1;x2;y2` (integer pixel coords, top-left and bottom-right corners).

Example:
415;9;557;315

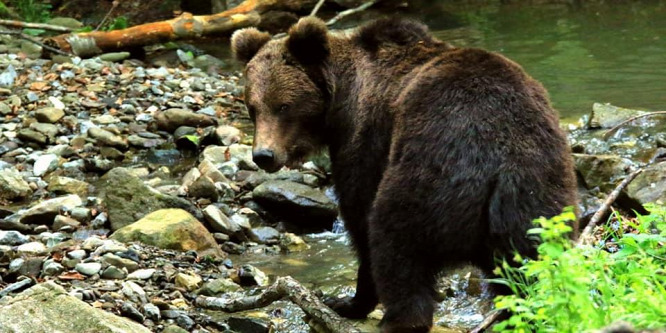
0;281;150;333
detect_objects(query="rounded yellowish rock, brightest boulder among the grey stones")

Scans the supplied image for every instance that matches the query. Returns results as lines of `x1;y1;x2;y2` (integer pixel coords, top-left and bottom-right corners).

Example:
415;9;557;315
111;209;224;258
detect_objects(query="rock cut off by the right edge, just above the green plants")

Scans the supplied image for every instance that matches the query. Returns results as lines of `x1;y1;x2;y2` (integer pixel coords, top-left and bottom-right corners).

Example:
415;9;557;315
627;162;666;205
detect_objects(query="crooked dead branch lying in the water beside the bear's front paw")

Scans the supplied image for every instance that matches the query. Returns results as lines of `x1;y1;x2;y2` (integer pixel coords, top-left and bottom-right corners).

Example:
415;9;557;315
195;276;360;333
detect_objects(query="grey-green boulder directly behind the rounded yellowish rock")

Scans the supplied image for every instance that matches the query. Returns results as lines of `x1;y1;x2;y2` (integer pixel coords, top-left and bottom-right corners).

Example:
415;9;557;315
100;168;198;230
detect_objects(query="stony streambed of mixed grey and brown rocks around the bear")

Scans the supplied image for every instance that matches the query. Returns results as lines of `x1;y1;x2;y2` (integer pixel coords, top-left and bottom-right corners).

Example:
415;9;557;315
0;35;666;332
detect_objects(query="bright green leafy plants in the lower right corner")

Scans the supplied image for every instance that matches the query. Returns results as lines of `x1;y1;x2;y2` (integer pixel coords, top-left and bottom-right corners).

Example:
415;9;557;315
494;206;666;332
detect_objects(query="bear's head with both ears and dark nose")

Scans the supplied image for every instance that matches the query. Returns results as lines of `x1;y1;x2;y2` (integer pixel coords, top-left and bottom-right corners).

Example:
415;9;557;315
231;17;330;172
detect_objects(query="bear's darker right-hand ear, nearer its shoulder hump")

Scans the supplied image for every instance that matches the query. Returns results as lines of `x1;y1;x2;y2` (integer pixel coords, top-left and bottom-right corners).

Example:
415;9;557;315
287;16;329;65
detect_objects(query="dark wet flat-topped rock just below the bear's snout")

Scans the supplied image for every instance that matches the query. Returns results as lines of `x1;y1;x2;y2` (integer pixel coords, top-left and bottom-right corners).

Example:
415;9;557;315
252;180;338;227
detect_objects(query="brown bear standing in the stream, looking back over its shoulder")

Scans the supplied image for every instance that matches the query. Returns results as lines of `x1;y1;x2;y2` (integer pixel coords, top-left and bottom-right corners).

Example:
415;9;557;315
232;17;576;332
